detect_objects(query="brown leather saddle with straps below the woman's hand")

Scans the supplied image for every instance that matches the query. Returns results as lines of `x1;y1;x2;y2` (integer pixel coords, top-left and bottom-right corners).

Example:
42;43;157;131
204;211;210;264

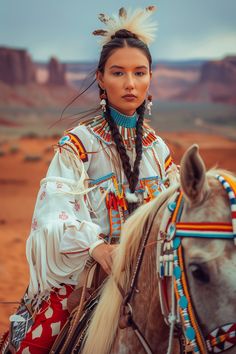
50;261;107;354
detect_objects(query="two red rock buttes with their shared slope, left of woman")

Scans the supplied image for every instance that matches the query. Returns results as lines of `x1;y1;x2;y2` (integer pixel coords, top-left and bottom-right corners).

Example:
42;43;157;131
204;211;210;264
0;47;76;109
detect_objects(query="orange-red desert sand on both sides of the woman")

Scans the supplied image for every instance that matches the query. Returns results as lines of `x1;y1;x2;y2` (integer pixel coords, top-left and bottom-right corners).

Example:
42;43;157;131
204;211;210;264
0;132;236;332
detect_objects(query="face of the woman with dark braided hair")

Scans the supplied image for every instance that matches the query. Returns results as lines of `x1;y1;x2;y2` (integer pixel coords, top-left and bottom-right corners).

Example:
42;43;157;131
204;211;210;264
97;47;152;116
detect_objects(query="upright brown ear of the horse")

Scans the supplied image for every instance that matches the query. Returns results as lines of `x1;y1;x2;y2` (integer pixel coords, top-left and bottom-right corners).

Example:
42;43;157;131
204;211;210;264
180;144;208;204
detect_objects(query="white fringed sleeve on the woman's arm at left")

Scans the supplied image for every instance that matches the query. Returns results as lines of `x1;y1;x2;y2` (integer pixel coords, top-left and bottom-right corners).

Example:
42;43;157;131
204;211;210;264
26;133;101;296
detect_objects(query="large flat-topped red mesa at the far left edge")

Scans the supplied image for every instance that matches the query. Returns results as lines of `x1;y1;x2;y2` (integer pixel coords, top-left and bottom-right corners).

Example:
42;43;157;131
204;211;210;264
0;47;36;85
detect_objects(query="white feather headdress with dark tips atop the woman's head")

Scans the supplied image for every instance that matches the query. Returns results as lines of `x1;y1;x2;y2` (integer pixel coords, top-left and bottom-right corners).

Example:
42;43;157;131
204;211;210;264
93;6;157;45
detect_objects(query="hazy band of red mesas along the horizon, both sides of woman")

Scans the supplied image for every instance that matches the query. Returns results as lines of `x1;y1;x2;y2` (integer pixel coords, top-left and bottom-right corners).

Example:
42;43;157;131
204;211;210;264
0;47;236;107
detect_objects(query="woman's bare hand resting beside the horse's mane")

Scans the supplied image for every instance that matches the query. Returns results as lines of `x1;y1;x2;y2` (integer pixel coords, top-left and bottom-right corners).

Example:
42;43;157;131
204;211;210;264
92;243;117;274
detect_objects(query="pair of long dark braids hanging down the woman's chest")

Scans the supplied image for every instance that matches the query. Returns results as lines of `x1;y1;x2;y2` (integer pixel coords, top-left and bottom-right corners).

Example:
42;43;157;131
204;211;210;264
104;97;146;213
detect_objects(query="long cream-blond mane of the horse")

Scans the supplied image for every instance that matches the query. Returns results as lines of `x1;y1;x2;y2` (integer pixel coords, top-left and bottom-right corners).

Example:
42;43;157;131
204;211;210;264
83;169;236;354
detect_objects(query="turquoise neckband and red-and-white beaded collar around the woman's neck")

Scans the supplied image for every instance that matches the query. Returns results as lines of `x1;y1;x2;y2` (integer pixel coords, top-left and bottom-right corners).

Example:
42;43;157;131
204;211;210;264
81;107;158;150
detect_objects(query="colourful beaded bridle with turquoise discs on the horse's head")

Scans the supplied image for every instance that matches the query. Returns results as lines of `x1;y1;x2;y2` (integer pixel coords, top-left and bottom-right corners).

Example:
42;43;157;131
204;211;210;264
159;175;236;354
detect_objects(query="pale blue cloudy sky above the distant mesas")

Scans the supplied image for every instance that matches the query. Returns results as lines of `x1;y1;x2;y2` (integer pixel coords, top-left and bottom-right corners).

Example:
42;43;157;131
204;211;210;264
0;0;236;61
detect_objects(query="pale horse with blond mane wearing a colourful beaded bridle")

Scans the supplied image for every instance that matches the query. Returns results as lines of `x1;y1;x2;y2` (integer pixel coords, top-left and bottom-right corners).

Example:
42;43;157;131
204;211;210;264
57;145;236;354
